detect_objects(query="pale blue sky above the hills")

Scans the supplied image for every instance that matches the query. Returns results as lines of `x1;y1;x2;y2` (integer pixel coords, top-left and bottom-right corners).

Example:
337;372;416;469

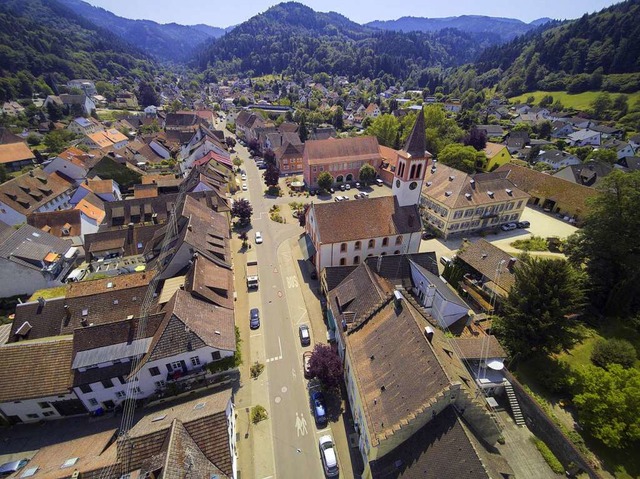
85;0;618;27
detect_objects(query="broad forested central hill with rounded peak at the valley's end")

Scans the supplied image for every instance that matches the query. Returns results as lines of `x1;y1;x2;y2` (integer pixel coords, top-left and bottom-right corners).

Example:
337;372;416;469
197;2;493;83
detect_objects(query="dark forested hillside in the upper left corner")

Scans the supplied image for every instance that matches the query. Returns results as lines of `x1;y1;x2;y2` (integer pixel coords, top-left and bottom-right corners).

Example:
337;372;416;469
0;0;154;100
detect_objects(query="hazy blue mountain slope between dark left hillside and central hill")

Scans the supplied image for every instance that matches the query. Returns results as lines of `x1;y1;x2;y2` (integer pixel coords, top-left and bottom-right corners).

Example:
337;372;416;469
58;0;227;62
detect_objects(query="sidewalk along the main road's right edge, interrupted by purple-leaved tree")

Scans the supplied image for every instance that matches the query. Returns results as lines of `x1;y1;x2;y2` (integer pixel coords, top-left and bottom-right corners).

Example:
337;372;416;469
286;237;363;478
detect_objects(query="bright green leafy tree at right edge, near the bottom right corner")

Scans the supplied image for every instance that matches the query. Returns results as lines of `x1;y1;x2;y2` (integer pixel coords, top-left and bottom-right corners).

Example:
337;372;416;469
573;364;640;449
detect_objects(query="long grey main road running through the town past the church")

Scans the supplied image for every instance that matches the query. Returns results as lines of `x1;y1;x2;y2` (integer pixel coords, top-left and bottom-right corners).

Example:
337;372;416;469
235;134;329;479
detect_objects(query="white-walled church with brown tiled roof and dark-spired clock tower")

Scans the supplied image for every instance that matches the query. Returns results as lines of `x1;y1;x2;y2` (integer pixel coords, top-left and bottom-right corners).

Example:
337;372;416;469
299;111;431;273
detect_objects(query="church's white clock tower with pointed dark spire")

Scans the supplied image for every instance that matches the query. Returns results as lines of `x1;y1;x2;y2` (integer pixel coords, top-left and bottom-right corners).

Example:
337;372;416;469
392;110;431;206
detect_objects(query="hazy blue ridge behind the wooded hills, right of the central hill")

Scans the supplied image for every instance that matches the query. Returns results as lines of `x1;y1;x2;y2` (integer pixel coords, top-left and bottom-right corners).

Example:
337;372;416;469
366;15;551;42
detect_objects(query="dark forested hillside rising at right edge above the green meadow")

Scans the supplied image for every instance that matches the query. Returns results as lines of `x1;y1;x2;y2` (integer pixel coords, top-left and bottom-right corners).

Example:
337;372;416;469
475;0;640;96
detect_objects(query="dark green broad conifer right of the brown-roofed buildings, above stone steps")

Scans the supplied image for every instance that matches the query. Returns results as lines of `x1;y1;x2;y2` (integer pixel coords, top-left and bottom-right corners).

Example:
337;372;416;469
496;255;584;356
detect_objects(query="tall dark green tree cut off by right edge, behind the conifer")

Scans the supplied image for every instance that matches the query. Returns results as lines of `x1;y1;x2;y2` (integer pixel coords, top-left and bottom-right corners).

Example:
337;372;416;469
566;170;640;314
